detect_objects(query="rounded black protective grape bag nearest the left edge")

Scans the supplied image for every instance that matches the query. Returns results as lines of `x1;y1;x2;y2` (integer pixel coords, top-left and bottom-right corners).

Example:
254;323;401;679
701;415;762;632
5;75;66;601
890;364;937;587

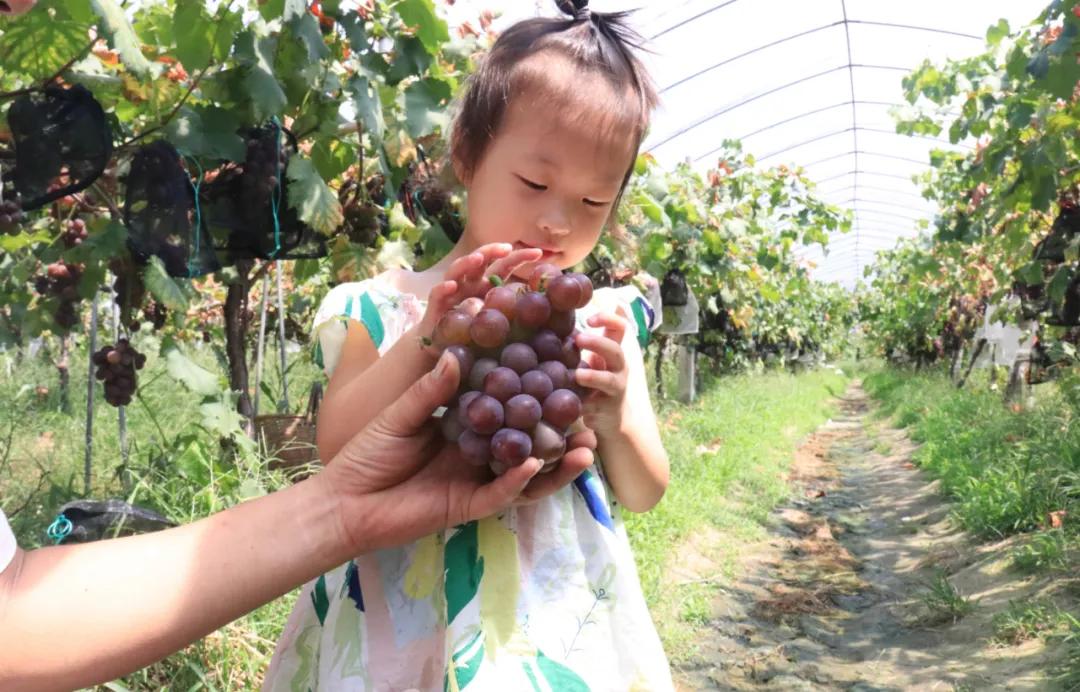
4;84;112;209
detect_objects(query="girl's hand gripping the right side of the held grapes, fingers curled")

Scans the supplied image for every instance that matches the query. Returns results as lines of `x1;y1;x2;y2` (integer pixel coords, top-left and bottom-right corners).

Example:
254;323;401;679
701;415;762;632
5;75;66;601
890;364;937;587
576;312;629;437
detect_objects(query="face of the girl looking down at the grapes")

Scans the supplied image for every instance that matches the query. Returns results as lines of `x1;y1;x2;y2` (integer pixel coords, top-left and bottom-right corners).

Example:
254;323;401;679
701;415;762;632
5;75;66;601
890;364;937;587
459;83;637;275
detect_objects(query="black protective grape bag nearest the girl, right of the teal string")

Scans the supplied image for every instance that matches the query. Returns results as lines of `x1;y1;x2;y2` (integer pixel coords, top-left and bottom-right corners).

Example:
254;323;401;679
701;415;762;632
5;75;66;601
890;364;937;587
200;122;327;263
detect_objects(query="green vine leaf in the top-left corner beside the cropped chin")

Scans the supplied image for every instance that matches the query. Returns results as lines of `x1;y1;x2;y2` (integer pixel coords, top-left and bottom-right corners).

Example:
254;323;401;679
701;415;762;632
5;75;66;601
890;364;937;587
0;11;90;81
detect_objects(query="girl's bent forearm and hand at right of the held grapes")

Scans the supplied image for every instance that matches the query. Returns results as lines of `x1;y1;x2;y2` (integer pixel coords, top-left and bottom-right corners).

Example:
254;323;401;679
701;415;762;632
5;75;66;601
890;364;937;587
577;313;670;512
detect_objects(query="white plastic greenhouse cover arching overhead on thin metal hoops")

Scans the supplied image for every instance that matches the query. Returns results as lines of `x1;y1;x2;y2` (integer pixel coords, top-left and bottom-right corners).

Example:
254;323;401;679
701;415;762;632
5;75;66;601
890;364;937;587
448;0;1048;286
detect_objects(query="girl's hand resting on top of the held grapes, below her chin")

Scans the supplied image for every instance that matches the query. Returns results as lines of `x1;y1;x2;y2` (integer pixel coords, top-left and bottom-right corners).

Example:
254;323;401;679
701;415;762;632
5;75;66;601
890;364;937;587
419;243;543;337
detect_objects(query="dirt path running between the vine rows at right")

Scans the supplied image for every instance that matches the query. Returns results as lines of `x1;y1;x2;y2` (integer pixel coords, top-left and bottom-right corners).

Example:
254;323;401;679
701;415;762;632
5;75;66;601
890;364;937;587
676;384;1062;692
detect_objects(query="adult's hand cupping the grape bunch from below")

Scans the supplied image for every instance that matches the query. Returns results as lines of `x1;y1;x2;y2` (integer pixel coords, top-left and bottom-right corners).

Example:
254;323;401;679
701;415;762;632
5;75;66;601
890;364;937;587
312;347;595;553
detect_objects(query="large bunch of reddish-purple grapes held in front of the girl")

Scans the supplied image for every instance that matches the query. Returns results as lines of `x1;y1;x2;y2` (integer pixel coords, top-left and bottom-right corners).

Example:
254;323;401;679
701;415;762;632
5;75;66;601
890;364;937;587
433;264;593;474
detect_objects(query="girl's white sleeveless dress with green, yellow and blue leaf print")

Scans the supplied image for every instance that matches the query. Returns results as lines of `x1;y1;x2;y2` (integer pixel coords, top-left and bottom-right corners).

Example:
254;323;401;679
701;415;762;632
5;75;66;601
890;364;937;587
264;279;672;692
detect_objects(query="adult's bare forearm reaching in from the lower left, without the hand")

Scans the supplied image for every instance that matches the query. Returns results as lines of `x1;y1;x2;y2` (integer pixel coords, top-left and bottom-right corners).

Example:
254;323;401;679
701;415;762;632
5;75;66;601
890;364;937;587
0;476;349;690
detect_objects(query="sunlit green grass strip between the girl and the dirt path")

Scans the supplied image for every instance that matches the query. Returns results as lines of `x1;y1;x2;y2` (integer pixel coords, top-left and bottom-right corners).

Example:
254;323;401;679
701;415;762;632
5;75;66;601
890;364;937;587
623;362;847;662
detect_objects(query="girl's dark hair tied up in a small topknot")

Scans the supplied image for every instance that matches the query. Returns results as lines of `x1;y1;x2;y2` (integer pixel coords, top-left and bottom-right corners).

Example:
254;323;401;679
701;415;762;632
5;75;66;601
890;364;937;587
450;0;658;195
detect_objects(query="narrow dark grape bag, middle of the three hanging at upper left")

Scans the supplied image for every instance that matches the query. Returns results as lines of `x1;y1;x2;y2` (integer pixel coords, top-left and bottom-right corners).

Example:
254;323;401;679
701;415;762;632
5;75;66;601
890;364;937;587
124;139;220;279
